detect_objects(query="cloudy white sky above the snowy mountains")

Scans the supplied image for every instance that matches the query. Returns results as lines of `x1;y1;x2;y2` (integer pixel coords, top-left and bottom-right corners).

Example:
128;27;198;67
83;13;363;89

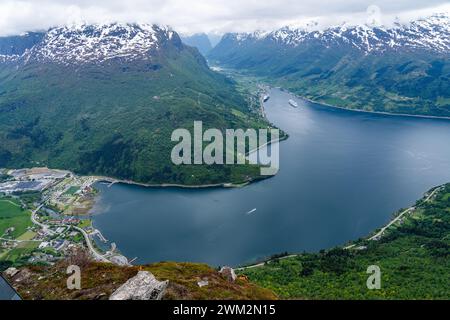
0;0;450;35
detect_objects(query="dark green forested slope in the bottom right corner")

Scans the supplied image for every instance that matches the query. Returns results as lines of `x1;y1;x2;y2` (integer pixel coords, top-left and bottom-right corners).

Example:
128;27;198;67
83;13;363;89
244;184;450;299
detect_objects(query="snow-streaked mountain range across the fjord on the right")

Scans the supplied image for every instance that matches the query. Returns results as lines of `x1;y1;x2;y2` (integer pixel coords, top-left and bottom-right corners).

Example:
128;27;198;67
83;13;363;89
208;14;450;116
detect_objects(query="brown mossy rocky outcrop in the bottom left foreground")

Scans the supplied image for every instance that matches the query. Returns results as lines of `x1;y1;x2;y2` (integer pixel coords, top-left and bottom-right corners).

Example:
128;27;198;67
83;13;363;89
3;259;277;300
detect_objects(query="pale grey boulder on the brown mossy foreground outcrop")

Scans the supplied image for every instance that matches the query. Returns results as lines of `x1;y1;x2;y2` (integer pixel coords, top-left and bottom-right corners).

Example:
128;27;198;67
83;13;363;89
109;271;169;300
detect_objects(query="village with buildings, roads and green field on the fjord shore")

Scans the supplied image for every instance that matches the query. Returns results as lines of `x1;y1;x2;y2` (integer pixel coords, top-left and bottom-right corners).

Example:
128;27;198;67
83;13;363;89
0;168;129;267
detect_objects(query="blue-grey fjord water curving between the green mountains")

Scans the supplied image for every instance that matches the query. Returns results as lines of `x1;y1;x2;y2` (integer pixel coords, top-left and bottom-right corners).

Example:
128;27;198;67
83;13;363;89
90;89;450;266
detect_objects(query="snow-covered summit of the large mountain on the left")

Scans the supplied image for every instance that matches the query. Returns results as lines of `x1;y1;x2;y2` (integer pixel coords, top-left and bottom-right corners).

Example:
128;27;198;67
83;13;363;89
0;23;181;65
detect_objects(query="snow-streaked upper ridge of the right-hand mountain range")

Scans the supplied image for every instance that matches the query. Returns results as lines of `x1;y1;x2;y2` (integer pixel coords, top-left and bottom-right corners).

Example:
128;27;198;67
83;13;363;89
227;14;450;52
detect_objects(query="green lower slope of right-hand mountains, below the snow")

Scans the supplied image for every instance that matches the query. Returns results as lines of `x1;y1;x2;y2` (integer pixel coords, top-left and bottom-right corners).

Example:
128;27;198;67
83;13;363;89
208;26;450;117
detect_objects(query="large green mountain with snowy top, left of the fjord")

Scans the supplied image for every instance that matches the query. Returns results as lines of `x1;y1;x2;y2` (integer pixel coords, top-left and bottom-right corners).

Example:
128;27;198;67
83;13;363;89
0;24;264;184
